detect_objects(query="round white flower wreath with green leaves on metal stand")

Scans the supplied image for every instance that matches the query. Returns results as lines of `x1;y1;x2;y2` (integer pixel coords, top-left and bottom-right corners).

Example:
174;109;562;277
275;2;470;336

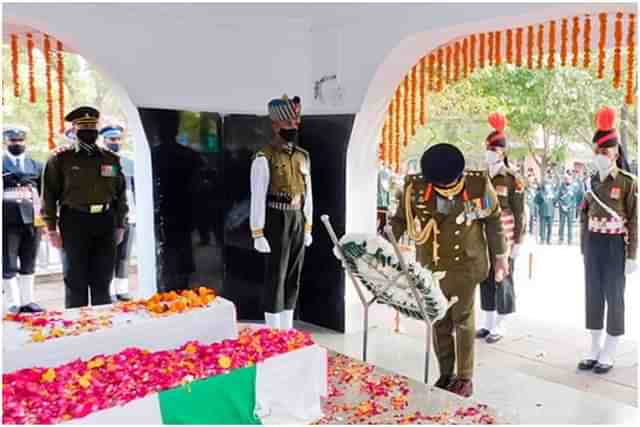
333;234;448;322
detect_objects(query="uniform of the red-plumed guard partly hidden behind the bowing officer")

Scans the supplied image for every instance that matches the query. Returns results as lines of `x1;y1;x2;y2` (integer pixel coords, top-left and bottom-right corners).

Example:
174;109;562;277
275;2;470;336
480;166;525;314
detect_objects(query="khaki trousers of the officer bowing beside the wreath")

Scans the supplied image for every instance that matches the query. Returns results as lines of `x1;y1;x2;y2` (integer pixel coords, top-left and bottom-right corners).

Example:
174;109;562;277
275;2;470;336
433;271;476;380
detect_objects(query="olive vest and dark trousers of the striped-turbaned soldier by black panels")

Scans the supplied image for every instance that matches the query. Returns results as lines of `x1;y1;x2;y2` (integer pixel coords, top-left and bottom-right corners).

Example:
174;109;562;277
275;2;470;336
252;143;312;313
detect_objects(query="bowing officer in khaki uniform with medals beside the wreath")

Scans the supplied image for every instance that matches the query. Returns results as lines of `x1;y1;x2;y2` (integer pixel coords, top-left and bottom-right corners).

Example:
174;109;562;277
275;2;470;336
391;144;508;397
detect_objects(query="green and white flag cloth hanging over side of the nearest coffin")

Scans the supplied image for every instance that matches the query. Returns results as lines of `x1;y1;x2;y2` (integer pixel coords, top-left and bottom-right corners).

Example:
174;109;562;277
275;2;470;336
71;345;327;425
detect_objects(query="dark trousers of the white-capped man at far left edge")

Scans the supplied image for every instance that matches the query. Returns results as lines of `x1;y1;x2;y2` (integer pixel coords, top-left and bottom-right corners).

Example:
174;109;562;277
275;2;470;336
2;224;42;279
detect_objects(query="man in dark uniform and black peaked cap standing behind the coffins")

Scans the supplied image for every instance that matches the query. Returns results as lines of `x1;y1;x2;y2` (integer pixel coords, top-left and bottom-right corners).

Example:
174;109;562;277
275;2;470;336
42;107;128;308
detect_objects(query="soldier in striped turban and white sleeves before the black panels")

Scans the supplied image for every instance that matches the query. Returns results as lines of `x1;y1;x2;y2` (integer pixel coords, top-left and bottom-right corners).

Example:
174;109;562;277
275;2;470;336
250;95;313;329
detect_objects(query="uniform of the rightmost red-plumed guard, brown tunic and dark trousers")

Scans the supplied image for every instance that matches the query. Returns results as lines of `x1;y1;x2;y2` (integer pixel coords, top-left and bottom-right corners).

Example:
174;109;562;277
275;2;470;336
580;169;638;337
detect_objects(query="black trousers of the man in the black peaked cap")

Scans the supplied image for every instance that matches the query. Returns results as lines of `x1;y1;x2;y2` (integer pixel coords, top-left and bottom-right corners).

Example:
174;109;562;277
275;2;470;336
60;207;116;308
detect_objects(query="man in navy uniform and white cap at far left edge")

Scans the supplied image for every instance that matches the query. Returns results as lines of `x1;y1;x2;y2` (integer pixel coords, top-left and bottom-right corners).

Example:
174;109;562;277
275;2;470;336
2;126;43;313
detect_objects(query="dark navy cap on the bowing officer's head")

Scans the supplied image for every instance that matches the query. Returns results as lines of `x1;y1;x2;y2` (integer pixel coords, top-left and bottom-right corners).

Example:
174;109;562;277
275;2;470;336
420;144;465;184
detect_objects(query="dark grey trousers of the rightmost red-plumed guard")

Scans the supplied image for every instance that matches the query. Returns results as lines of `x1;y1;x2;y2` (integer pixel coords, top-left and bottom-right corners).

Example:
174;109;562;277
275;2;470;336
584;232;626;337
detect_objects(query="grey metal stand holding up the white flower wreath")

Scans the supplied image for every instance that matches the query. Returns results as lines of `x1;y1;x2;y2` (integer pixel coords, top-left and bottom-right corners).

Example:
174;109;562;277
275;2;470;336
321;215;458;384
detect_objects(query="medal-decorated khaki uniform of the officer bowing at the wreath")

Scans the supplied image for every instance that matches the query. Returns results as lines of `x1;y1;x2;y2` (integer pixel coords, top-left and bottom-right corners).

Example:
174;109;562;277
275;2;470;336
391;171;506;379
